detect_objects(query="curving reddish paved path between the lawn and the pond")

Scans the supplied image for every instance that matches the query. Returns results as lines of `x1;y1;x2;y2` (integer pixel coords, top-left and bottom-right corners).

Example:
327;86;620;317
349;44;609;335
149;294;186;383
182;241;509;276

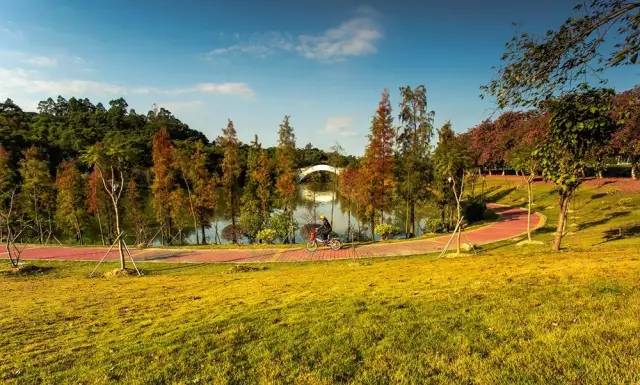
0;204;542;263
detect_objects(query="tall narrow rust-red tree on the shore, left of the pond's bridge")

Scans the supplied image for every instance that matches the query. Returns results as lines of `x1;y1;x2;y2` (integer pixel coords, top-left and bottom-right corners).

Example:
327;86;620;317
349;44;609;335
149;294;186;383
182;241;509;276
151;128;175;243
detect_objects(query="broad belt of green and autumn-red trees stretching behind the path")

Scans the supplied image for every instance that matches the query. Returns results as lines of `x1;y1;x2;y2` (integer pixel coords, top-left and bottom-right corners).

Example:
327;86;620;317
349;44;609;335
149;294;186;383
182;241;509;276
0;86;640;256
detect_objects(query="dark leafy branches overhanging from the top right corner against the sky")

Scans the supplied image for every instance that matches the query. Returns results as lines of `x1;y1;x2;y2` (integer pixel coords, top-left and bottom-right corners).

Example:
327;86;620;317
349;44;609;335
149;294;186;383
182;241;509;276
483;0;640;107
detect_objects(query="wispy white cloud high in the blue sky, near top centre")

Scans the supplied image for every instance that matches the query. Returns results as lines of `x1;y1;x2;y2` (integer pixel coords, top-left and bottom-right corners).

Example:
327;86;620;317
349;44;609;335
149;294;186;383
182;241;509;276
205;8;382;62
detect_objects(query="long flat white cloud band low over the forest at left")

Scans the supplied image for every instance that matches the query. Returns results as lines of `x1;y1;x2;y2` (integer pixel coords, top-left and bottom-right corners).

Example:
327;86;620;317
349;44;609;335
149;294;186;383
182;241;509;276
0;67;254;97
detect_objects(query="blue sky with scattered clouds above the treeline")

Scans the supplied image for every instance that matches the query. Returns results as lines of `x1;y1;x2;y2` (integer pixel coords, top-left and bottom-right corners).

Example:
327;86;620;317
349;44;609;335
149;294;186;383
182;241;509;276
0;0;638;154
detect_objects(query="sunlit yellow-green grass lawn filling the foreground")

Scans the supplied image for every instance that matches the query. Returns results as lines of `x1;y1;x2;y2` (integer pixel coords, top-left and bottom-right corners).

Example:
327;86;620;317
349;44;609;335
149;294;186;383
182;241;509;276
0;179;640;384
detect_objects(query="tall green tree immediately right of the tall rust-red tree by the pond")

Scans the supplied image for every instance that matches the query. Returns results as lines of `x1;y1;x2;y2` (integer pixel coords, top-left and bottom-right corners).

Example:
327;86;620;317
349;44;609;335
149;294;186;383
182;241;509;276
397;85;434;235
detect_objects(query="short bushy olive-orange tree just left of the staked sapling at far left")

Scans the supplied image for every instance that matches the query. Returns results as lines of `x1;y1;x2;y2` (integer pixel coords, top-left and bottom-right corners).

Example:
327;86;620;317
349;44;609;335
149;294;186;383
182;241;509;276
55;160;87;243
